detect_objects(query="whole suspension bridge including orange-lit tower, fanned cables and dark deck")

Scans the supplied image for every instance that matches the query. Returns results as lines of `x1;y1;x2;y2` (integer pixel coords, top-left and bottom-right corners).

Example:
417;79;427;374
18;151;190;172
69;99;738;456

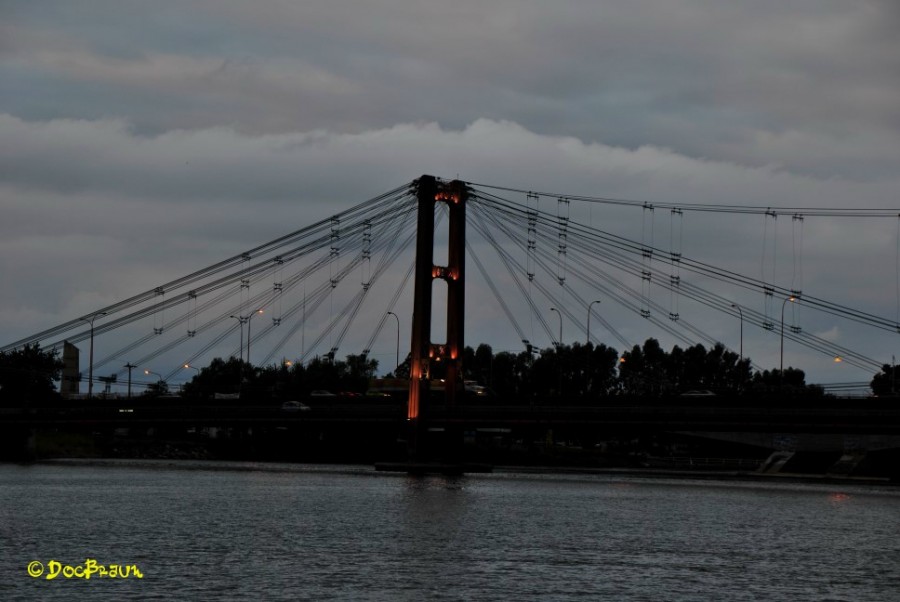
0;176;900;468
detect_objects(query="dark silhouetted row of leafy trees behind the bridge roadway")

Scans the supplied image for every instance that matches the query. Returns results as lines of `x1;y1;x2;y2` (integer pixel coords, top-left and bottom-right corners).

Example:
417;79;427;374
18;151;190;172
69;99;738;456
0;338;832;406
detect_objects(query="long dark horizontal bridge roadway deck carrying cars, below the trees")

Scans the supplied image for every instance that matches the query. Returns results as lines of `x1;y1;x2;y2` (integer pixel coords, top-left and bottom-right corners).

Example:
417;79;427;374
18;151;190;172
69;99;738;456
0;400;900;435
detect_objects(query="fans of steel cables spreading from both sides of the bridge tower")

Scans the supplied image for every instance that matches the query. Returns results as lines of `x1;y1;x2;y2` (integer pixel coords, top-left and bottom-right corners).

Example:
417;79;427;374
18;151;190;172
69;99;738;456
0;173;900;388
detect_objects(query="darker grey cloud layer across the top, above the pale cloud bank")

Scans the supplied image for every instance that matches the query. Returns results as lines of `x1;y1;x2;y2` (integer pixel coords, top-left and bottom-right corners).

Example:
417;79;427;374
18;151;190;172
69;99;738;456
4;0;900;178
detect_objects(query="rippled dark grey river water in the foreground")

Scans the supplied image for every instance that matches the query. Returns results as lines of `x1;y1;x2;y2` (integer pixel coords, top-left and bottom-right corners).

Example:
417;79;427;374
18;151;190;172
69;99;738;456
0;462;900;602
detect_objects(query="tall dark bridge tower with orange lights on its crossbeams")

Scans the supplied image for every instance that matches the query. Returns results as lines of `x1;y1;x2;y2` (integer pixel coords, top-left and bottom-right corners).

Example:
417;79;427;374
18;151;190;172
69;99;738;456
407;175;468;458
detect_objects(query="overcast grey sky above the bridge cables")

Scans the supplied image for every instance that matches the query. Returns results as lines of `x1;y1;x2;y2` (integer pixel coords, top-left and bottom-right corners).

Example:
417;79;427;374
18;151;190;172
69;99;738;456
0;0;900;382
